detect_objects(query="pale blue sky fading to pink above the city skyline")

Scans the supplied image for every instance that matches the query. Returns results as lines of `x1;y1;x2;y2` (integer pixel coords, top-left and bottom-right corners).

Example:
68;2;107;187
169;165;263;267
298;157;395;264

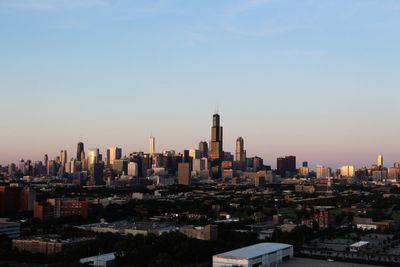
0;0;400;170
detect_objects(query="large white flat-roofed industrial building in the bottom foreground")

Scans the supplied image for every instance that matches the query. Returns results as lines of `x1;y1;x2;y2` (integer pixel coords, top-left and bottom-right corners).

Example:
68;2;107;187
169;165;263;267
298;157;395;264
213;243;293;267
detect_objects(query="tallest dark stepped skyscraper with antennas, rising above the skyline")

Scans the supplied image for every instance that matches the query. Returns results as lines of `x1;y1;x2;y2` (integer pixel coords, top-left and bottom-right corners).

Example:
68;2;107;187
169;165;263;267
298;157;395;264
210;114;224;165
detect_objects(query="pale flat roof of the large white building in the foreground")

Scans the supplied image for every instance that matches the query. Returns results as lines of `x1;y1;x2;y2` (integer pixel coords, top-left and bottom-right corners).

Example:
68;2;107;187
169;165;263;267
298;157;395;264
215;243;293;260
